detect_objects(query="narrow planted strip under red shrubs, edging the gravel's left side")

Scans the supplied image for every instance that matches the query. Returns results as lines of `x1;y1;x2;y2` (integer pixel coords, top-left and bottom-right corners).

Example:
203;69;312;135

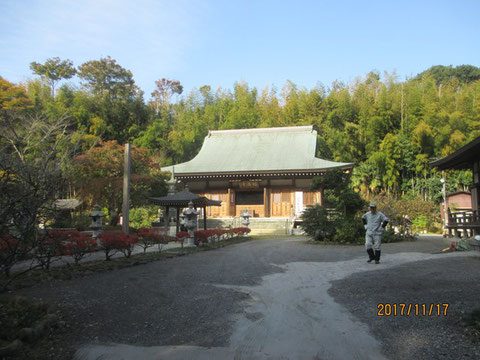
0;237;252;290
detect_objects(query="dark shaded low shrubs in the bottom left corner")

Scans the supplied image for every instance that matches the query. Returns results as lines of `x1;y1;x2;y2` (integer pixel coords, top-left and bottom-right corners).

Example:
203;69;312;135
0;297;48;347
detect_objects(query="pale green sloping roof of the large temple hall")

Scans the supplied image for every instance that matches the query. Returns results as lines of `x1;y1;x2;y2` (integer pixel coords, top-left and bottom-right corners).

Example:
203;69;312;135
162;126;353;175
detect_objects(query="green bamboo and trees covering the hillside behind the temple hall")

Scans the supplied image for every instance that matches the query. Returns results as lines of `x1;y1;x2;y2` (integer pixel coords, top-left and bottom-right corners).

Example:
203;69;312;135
0;57;480;205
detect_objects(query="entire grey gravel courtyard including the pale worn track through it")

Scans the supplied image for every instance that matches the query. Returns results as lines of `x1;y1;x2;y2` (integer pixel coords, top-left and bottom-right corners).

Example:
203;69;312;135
8;237;480;360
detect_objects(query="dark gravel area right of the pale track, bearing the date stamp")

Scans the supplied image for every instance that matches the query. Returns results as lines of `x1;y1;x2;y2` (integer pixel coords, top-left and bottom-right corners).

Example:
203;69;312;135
329;253;480;360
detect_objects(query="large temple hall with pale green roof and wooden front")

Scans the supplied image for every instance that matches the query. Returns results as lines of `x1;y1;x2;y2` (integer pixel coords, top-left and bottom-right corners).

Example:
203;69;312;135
162;126;353;218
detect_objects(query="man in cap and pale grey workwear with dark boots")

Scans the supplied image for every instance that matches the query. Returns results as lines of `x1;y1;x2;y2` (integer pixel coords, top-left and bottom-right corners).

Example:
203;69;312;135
362;202;389;264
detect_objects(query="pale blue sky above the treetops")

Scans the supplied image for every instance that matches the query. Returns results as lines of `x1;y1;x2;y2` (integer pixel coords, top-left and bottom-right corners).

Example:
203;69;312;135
0;0;480;98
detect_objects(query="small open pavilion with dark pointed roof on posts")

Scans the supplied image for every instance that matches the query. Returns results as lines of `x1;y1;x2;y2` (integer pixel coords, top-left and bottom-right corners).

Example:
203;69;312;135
150;187;221;233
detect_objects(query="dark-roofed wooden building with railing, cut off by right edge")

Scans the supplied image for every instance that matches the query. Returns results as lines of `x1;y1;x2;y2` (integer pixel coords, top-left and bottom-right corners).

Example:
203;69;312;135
430;136;480;234
